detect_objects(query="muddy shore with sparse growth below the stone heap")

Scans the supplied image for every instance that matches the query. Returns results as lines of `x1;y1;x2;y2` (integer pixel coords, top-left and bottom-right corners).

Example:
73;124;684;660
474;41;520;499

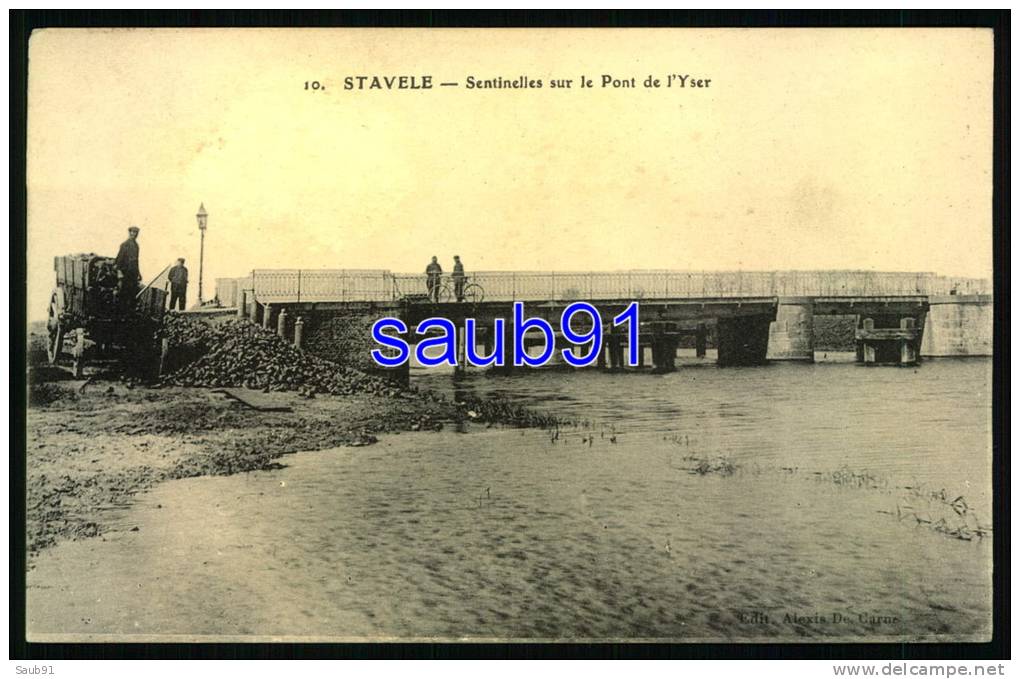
26;370;497;566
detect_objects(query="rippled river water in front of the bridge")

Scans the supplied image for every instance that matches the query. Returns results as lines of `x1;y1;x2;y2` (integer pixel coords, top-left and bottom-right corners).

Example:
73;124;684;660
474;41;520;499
28;355;992;641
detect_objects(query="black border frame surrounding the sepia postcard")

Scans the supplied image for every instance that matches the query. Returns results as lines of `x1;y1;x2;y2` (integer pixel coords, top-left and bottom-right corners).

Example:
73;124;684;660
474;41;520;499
9;9;1010;661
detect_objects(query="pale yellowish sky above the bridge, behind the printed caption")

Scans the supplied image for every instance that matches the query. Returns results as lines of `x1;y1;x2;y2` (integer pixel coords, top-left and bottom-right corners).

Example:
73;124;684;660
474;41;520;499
28;29;992;319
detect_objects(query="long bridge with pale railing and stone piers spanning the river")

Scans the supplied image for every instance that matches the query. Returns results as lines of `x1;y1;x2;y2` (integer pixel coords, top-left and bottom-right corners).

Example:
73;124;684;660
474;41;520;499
216;269;991;377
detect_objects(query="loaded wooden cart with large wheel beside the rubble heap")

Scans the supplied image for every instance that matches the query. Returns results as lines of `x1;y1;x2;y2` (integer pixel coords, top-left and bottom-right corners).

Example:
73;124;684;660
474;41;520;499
46;254;166;377
